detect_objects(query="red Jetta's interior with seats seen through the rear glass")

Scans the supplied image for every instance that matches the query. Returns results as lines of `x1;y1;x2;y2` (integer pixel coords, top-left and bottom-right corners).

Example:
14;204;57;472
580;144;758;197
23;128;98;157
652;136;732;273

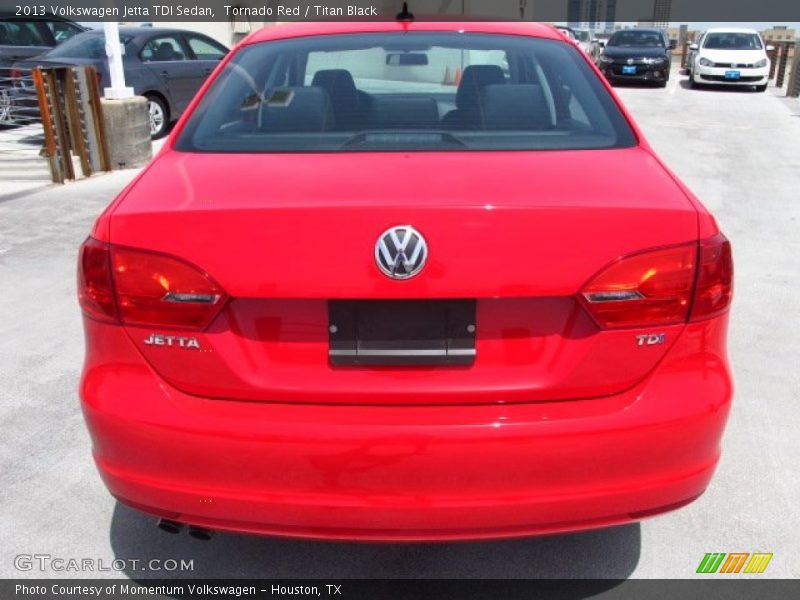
180;34;632;151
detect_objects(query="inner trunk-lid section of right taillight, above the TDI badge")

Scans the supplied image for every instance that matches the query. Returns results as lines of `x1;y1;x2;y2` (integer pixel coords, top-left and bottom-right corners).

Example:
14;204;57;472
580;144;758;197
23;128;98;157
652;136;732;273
580;244;697;329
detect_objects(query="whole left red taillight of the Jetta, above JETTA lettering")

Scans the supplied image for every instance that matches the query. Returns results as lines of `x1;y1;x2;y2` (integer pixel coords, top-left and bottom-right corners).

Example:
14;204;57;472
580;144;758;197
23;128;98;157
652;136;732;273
79;238;227;330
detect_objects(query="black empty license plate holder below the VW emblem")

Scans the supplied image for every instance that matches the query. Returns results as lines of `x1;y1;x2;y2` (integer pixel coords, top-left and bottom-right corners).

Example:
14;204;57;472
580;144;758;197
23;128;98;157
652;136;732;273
328;300;476;367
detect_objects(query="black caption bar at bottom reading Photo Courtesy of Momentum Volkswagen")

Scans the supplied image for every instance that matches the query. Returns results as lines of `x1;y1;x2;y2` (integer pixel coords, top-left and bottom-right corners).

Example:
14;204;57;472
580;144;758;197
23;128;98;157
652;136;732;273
0;574;800;600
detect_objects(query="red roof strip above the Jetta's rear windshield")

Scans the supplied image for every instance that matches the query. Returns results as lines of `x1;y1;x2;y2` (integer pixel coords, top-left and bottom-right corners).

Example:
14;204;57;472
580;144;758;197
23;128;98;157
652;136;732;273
247;21;563;44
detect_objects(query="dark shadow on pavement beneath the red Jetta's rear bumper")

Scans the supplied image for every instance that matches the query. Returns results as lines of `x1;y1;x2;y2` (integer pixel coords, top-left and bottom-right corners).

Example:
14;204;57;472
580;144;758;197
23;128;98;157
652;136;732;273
110;503;641;580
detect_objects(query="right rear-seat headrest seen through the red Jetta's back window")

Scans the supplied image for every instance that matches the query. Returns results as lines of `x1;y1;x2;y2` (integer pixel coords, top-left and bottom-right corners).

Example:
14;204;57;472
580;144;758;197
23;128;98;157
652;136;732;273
481;84;552;129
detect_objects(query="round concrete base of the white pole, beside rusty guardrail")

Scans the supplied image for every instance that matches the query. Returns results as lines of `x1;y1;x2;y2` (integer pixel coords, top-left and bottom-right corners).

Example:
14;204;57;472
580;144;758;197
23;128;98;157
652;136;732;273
100;96;153;170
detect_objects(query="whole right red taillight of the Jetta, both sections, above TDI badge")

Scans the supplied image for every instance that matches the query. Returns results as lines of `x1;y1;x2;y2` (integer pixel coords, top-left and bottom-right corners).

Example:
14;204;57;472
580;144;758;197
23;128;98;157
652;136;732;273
579;234;733;329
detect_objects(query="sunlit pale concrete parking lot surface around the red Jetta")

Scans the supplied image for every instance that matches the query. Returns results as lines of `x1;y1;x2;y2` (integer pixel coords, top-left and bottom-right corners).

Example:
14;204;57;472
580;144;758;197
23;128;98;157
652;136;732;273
0;77;800;579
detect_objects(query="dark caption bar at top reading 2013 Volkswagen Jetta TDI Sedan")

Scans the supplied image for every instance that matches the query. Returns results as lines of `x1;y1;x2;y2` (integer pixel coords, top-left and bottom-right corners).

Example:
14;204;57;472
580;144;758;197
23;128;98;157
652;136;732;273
0;0;800;24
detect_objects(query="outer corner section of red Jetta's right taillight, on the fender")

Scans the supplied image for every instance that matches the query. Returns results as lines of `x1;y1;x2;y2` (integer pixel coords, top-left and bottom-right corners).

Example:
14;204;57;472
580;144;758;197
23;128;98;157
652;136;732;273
691;233;733;321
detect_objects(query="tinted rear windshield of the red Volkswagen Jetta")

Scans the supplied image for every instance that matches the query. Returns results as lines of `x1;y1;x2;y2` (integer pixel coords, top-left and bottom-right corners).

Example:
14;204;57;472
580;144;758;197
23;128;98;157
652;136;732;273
176;32;635;152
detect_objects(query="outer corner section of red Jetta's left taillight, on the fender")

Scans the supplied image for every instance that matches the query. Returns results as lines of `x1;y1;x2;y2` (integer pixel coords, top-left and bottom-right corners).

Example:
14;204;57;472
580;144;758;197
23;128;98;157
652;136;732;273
78;238;117;322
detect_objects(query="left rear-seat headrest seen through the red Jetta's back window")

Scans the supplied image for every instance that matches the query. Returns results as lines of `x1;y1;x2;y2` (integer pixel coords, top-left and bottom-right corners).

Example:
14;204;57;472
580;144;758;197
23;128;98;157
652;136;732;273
260;86;334;133
